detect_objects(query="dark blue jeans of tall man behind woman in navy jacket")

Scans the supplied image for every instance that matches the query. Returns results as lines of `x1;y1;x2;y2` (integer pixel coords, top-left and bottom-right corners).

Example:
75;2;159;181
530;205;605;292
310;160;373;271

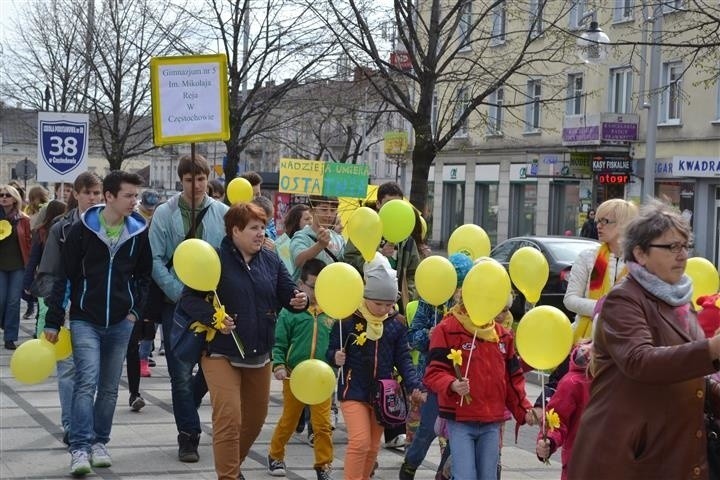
162;304;207;434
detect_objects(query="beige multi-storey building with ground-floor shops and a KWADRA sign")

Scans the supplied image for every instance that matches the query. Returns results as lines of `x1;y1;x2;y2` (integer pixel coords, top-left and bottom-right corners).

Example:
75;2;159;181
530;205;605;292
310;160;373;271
422;0;720;263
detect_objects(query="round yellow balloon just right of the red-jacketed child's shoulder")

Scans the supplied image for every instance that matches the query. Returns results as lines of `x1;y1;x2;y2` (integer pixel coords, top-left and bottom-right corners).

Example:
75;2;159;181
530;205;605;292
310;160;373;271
515;305;573;370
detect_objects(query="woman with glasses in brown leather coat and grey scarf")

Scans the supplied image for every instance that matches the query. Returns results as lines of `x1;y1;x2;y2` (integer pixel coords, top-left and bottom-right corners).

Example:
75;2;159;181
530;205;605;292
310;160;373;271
568;201;720;480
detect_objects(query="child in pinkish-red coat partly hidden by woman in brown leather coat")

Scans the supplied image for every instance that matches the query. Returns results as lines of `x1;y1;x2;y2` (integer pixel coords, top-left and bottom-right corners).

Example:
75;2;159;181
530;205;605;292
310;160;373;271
535;343;592;480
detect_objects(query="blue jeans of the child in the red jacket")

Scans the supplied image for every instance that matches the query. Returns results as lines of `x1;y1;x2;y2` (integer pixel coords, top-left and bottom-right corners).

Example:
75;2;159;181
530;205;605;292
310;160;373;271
448;420;501;480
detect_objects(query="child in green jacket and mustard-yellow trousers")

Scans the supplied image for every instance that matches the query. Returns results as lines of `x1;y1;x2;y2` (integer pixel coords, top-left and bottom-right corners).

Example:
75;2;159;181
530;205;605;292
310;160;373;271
268;258;333;480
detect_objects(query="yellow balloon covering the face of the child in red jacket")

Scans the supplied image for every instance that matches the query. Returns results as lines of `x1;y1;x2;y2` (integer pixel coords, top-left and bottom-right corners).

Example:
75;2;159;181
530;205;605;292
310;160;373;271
462;258;511;327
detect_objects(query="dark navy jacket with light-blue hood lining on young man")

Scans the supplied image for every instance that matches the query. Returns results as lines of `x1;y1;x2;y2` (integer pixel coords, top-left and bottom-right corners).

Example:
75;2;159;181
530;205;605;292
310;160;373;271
45;205;152;330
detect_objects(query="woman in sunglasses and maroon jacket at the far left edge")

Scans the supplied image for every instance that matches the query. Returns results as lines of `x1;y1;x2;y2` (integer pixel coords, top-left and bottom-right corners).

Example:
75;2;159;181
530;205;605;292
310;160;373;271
0;185;31;350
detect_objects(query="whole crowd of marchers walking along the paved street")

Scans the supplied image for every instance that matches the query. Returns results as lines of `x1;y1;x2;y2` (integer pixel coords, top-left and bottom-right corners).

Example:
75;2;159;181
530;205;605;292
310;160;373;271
0;162;720;480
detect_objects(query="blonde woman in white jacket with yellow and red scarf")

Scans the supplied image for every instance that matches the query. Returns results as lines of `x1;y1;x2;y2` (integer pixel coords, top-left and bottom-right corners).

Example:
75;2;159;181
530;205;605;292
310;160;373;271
563;198;638;343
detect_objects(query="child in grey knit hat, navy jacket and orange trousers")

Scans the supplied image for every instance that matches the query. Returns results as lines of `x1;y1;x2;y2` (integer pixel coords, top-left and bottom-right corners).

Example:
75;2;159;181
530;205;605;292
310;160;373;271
327;255;424;480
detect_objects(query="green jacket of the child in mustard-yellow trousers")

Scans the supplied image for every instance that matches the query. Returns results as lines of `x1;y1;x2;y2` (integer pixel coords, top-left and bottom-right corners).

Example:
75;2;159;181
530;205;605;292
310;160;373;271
273;307;333;373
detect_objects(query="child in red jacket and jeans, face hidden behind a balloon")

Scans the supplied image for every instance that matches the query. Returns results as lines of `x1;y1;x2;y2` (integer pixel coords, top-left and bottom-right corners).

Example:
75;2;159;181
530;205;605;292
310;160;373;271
423;304;535;480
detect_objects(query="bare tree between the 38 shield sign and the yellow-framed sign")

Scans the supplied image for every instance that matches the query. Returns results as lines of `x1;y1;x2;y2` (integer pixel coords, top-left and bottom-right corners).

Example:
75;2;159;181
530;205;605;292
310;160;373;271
85;0;197;169
